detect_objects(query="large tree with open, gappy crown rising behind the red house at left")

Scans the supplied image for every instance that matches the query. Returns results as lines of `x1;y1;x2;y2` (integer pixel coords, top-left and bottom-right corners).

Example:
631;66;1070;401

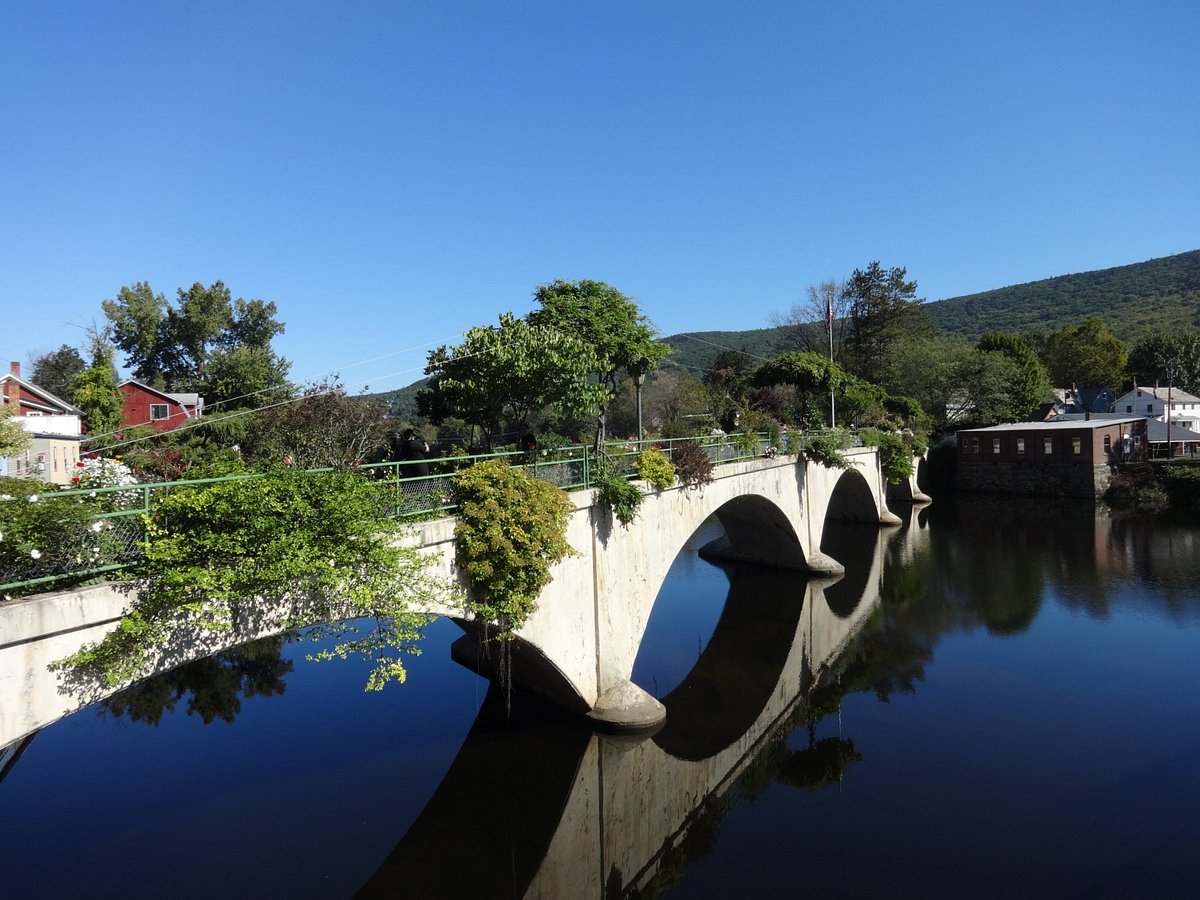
101;281;289;398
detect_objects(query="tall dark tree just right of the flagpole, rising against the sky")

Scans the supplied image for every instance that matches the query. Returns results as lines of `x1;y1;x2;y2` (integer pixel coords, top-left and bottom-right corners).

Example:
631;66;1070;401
846;260;932;377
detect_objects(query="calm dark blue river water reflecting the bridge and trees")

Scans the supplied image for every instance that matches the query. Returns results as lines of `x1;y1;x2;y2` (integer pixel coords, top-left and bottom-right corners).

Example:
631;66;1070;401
0;502;1200;898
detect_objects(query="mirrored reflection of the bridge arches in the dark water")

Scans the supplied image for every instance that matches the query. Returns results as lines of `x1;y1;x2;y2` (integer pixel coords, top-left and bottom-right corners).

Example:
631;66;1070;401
360;515;923;898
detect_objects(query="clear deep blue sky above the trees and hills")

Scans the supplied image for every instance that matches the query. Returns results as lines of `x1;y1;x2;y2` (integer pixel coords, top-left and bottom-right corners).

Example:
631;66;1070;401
0;0;1200;390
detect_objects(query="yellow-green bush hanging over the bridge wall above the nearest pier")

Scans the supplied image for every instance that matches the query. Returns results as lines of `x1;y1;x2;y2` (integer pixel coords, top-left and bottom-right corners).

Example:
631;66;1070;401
454;460;575;638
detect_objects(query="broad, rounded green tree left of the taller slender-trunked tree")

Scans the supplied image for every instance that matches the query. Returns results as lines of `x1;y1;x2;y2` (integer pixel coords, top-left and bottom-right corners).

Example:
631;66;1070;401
416;313;611;446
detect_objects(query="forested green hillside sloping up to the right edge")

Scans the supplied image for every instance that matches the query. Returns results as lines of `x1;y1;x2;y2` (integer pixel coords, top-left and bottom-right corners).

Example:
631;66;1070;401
928;250;1200;342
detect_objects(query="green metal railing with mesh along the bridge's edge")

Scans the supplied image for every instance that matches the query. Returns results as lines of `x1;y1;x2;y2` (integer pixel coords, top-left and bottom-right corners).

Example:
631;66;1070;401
0;433;786;600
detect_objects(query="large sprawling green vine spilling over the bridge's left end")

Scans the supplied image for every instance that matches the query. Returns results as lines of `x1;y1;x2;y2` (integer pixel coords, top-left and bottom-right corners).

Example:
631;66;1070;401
59;470;444;689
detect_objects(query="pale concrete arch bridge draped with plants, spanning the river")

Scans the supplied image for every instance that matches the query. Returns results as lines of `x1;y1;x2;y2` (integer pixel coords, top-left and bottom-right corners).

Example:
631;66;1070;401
0;448;916;748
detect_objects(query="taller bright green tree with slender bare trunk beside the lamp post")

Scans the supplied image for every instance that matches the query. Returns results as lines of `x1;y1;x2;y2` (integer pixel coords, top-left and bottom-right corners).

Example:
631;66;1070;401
527;280;671;445
